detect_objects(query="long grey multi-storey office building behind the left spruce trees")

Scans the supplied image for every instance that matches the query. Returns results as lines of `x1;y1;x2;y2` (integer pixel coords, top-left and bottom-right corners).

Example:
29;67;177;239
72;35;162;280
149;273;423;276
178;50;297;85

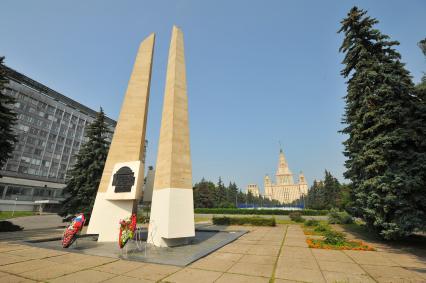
0;66;116;211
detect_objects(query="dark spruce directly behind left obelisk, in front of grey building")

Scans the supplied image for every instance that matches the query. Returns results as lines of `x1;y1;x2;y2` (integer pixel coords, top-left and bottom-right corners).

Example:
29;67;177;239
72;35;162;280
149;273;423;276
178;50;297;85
60;108;110;216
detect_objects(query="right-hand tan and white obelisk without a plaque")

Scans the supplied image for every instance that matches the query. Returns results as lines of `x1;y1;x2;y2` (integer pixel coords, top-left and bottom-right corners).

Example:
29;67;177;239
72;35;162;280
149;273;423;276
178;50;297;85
148;26;195;247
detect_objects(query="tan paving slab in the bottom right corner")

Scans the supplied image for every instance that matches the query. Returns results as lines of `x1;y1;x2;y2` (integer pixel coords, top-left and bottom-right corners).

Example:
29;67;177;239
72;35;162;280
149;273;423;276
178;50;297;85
362;265;424;282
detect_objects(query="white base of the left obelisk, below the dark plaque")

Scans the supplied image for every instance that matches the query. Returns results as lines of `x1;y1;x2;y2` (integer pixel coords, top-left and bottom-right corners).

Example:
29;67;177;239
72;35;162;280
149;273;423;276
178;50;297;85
87;193;135;242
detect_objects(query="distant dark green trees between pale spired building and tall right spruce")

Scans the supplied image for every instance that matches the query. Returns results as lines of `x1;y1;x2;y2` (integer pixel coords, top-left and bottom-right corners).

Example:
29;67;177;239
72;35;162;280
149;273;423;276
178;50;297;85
306;170;349;209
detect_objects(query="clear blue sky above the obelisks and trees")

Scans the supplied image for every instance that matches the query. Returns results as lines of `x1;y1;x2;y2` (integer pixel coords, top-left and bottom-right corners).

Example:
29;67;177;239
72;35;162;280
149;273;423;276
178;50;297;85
0;0;426;193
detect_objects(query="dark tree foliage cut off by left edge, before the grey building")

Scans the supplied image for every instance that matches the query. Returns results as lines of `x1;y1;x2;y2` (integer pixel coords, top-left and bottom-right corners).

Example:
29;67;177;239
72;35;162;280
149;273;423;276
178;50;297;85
0;57;17;173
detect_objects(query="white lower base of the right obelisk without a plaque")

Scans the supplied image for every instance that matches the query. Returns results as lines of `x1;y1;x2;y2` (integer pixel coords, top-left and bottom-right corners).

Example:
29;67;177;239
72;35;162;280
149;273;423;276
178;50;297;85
148;188;195;247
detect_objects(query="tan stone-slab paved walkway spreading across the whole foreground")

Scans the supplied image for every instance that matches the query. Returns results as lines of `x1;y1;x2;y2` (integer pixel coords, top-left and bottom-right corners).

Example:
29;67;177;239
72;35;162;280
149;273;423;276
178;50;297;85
0;225;426;283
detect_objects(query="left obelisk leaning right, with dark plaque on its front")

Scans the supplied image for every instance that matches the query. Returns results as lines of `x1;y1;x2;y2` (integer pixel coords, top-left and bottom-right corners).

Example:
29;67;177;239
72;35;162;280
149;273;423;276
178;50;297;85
87;34;155;242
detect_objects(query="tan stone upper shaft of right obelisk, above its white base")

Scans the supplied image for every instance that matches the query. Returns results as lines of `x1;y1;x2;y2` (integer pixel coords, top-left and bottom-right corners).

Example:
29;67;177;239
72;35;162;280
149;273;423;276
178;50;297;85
150;26;192;190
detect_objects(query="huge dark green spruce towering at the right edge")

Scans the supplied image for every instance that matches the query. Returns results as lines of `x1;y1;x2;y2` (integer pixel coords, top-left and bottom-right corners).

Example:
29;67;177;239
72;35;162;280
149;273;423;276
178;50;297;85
339;7;426;239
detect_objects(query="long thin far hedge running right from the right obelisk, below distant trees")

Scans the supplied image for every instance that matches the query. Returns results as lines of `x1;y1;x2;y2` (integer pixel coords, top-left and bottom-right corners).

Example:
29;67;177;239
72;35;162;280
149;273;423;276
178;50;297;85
194;208;328;216
